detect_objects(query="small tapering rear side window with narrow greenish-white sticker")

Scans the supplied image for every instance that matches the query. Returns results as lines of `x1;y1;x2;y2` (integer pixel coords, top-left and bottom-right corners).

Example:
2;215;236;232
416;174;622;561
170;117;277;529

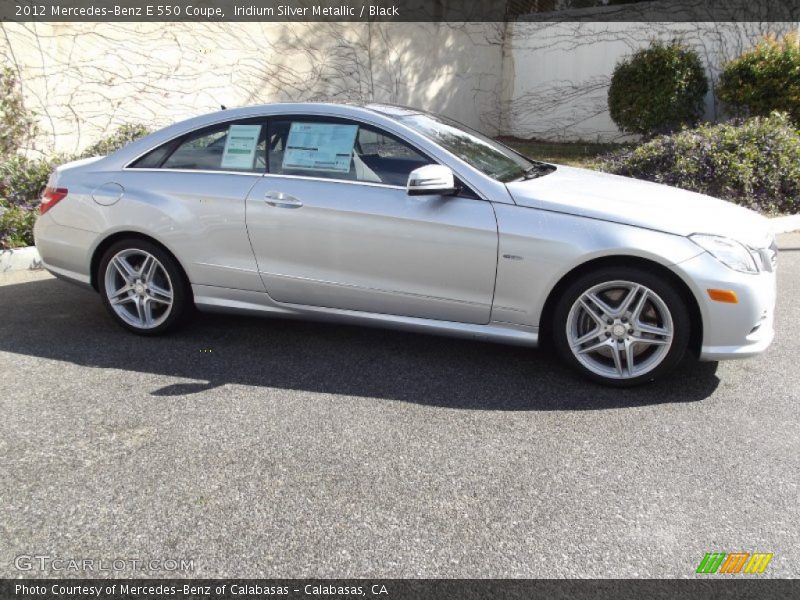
131;120;266;172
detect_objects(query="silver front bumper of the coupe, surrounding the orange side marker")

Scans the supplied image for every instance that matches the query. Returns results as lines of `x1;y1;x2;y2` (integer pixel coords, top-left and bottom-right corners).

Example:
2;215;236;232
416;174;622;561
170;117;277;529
675;253;776;361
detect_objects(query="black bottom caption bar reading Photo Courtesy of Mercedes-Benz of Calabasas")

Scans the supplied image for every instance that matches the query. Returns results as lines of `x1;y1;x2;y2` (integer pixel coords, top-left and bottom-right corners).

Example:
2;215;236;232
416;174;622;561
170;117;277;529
0;578;800;600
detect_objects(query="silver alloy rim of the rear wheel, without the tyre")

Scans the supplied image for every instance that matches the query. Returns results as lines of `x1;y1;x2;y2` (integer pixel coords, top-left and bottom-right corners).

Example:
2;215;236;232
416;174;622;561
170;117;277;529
105;248;174;329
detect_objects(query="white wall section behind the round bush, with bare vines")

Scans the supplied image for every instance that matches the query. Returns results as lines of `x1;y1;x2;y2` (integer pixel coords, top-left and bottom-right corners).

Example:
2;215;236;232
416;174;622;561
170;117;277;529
500;22;797;141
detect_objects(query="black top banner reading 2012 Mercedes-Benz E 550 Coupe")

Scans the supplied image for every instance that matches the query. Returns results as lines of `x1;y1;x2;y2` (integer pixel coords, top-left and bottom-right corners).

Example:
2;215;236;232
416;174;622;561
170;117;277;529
0;0;800;22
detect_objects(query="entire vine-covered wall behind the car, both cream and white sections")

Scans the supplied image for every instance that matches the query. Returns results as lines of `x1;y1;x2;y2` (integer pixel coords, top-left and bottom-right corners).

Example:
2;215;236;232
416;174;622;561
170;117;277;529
0;22;797;153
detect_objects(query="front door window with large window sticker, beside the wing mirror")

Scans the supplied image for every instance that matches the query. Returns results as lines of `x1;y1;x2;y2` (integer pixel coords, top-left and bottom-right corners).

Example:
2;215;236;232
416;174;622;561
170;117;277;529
269;119;433;186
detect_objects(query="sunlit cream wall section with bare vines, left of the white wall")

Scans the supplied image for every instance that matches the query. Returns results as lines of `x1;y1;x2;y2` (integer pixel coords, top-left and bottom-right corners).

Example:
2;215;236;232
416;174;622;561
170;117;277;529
0;23;504;153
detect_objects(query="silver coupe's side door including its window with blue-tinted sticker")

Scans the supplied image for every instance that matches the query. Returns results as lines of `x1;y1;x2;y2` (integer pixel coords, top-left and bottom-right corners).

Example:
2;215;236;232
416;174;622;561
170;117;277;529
247;117;497;323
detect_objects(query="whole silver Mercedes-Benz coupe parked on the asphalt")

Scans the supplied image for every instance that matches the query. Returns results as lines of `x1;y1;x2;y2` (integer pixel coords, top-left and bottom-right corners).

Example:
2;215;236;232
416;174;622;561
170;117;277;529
35;103;777;386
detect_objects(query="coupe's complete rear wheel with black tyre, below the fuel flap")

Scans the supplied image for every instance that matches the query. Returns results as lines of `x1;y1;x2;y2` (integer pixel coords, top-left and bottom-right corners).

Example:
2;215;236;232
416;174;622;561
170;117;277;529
97;239;189;335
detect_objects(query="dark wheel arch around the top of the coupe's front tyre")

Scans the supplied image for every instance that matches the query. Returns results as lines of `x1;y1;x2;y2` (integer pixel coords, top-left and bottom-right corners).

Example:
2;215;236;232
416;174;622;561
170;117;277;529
539;255;703;356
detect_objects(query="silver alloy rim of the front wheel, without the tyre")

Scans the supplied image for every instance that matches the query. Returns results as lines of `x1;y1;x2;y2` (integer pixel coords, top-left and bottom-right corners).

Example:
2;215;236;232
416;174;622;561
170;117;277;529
567;281;674;379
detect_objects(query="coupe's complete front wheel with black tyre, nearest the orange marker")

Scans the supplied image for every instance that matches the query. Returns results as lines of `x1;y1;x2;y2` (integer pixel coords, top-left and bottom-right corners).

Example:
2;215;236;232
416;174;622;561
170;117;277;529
553;267;691;387
